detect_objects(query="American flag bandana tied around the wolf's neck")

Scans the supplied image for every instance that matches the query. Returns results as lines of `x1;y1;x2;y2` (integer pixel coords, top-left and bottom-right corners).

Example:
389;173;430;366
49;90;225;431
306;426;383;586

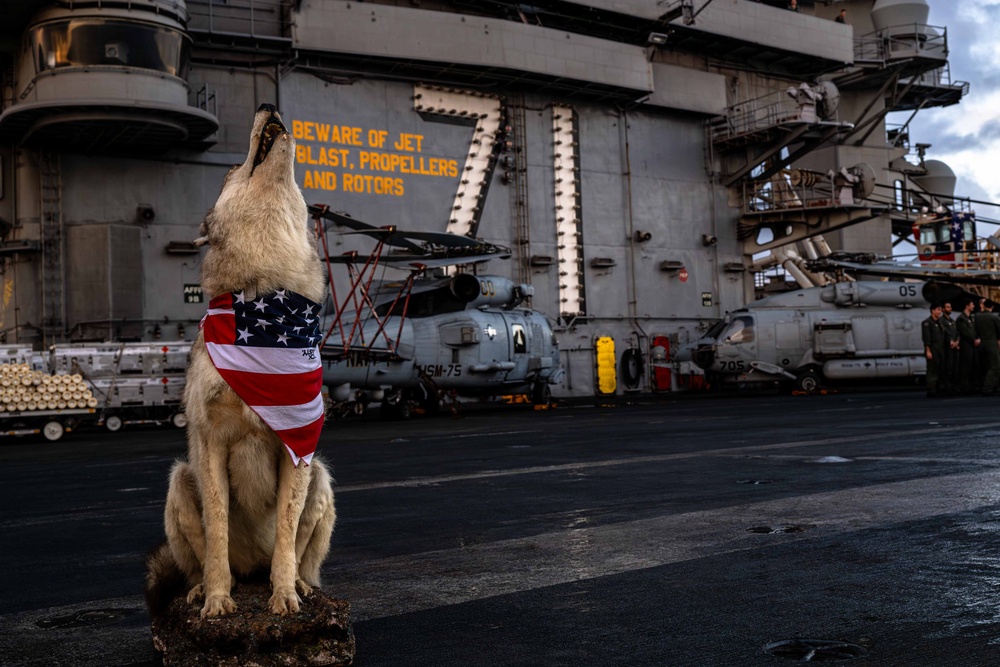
201;290;324;465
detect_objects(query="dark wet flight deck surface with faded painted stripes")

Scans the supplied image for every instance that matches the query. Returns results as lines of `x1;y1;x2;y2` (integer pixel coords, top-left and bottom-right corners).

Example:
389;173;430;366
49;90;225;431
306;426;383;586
0;392;1000;667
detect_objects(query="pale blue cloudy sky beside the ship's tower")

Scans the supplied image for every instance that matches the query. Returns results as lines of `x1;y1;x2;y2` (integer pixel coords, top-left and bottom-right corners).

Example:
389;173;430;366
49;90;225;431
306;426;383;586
888;0;1000;227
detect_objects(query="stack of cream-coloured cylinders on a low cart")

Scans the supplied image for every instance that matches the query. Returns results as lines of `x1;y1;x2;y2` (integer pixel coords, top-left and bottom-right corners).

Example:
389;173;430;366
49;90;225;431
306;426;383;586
0;364;97;412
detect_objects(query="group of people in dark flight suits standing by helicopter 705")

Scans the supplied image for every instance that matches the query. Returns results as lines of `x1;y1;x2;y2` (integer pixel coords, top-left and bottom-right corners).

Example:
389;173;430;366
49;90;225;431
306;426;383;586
921;298;1000;398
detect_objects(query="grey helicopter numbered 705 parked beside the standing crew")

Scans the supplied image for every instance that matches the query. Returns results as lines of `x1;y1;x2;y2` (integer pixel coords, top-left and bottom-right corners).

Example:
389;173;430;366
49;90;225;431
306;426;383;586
675;253;1000;392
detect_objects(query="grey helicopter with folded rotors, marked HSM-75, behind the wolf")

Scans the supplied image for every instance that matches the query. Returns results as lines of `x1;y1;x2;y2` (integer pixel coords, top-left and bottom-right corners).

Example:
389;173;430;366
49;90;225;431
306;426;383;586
309;205;563;419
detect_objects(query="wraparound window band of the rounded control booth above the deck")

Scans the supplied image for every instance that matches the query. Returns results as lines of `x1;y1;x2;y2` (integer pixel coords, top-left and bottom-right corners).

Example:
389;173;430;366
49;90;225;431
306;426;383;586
30;19;190;78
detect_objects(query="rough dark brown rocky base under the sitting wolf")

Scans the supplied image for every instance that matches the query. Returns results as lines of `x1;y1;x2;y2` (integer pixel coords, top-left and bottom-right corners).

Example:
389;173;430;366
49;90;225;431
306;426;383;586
153;583;355;667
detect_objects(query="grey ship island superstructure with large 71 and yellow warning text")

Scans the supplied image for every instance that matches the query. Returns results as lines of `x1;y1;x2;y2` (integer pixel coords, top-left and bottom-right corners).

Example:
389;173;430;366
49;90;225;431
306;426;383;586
0;0;968;396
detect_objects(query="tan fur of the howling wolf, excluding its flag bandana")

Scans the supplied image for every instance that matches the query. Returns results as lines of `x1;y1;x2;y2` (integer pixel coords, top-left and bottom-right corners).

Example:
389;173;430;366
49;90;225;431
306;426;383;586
147;105;336;618
